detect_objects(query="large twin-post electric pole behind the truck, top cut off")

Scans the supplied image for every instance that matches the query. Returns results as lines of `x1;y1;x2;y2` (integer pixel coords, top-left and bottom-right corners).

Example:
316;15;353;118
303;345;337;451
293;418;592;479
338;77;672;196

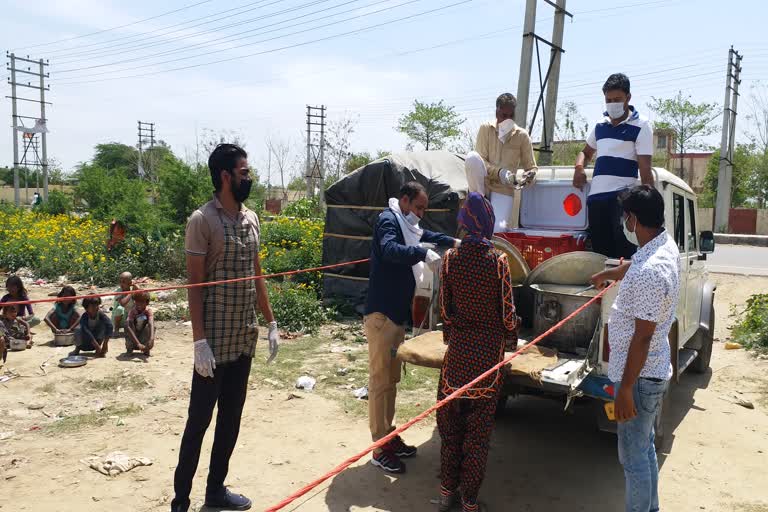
515;0;573;165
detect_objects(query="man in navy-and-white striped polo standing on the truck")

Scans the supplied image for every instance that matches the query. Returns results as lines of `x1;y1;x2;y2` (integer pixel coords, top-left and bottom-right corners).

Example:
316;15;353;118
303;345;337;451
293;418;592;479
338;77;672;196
573;73;653;258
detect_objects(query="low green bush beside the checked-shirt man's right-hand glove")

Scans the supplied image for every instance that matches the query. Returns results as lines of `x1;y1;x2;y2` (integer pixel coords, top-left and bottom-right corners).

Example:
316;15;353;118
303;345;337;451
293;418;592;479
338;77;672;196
262;281;333;334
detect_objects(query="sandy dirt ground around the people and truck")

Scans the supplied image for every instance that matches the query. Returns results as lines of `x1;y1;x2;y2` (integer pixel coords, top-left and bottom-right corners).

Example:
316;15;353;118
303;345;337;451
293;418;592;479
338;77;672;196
0;275;768;512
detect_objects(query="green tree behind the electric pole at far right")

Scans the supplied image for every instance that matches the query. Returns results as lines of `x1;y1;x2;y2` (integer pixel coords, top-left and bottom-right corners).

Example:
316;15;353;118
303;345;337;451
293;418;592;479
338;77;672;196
699;144;758;208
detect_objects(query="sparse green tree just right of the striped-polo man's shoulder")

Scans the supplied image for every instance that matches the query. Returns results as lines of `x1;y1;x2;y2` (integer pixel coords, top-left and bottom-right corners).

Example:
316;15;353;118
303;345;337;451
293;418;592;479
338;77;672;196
648;91;718;178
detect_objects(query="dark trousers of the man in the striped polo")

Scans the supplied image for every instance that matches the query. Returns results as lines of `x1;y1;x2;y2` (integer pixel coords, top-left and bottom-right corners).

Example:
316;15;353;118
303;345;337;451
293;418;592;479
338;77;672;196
589;197;637;259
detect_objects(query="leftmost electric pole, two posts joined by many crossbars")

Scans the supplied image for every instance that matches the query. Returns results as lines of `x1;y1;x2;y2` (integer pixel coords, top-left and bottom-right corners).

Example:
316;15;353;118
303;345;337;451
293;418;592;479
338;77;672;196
6;53;50;206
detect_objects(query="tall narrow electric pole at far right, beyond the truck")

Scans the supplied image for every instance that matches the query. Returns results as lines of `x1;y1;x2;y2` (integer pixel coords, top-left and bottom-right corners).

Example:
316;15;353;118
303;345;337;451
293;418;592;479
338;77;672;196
714;46;742;233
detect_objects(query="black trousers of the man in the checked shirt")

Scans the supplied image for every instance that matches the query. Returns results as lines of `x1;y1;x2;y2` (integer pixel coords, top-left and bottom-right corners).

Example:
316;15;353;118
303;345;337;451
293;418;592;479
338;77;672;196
172;356;251;505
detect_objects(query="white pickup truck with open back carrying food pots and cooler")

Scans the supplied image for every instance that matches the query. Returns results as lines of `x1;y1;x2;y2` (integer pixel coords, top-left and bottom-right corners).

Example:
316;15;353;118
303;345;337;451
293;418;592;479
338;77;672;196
406;167;715;446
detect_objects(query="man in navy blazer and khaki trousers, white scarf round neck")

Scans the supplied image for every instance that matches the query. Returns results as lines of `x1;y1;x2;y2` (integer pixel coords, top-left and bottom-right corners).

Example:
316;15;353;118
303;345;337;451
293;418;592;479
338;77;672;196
363;182;458;473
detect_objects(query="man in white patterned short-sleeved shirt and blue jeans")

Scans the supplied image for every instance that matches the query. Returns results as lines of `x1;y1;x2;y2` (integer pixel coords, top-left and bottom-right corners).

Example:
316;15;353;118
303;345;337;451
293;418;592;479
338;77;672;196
592;185;680;512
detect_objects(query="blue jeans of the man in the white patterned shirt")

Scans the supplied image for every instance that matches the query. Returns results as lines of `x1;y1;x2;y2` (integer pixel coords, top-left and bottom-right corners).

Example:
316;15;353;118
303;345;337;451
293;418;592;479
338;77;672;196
615;378;669;512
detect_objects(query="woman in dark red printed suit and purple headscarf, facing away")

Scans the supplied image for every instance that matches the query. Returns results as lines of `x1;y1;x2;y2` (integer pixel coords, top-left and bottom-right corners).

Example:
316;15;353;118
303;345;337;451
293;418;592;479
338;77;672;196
437;192;517;512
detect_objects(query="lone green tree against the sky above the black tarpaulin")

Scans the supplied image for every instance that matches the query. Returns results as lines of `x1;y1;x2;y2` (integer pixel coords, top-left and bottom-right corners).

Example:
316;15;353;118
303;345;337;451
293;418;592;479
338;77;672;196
397;100;464;150
